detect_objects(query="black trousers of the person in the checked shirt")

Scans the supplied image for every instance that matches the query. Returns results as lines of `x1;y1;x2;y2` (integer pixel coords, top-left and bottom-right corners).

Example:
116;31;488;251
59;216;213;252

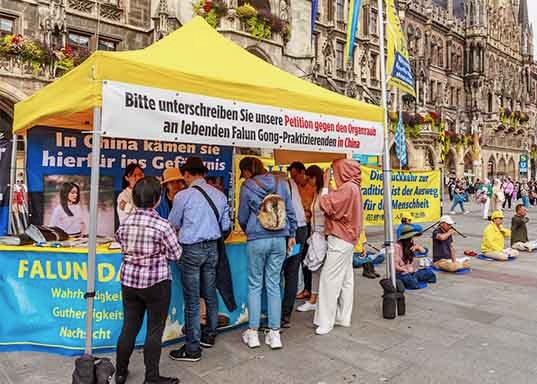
116;280;171;381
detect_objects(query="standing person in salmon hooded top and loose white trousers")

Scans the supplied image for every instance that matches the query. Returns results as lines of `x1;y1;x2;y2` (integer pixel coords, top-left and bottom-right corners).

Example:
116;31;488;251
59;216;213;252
314;159;363;335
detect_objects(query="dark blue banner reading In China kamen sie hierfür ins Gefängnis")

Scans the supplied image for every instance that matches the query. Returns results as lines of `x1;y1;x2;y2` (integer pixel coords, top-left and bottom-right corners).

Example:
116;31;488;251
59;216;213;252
27;127;233;236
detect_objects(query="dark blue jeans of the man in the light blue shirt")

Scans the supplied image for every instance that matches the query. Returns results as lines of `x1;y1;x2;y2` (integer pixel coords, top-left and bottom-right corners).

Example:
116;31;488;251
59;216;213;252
178;241;218;353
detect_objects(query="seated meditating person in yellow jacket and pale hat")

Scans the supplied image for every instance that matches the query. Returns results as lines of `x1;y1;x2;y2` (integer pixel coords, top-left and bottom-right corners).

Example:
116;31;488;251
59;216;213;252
481;211;518;261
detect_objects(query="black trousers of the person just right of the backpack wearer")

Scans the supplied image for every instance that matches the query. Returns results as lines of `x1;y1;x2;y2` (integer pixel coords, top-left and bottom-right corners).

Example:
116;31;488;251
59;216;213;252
282;226;308;318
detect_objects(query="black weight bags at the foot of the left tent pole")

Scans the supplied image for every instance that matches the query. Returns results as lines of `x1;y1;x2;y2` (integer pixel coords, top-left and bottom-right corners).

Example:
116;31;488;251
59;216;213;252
73;355;116;384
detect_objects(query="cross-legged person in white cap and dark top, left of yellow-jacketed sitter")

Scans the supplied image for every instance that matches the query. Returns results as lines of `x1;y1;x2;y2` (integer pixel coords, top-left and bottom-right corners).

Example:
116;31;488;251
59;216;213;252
433;215;470;273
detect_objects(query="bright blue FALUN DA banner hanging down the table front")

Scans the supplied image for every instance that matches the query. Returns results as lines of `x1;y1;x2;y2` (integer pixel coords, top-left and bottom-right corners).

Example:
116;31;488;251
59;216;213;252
0;244;248;355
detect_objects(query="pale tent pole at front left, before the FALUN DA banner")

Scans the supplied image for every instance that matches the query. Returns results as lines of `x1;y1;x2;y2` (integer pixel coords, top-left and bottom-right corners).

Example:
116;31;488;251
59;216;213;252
85;107;101;355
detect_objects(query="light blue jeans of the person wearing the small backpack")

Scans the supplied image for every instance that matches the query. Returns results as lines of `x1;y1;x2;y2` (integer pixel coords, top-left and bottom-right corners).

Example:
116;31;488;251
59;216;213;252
246;237;286;329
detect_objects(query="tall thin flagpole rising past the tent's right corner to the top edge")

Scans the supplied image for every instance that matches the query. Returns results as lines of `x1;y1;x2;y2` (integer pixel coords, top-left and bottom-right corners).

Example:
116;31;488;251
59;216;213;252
378;0;395;287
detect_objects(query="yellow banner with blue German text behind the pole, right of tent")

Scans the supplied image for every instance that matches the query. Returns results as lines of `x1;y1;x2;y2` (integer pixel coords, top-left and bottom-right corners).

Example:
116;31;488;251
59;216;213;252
362;166;441;226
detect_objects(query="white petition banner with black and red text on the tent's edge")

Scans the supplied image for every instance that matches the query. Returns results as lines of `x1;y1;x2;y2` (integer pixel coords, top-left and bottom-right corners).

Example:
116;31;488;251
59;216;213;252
102;81;383;154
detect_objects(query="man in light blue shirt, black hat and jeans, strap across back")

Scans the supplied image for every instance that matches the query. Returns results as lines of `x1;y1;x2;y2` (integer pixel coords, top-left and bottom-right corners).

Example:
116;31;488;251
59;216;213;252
168;157;231;362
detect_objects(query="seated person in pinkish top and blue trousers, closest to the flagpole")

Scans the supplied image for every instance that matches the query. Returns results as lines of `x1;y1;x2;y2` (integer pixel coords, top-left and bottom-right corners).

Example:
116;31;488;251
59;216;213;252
395;225;436;289
